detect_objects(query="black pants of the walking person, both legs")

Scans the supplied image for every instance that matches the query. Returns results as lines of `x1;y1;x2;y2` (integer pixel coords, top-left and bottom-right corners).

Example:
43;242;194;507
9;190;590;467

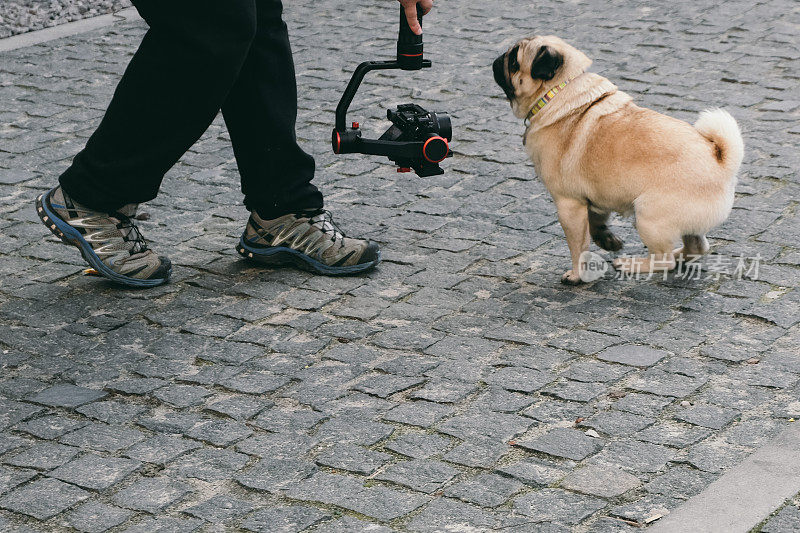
59;0;322;218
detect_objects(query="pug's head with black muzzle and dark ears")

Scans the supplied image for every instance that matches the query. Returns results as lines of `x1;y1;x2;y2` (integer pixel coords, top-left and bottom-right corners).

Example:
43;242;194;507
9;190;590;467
492;35;591;118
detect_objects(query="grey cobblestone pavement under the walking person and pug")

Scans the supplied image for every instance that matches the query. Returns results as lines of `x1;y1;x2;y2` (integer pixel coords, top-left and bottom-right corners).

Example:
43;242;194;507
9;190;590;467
0;0;800;533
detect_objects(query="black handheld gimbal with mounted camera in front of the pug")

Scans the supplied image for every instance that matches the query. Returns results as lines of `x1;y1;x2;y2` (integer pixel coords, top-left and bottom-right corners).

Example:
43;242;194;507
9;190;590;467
331;6;453;177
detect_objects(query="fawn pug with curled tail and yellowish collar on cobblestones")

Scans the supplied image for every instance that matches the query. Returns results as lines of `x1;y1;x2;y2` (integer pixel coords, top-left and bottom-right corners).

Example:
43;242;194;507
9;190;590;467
493;36;744;284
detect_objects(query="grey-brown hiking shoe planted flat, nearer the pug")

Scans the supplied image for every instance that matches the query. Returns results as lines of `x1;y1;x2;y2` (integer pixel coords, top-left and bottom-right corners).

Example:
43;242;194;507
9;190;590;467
236;209;381;276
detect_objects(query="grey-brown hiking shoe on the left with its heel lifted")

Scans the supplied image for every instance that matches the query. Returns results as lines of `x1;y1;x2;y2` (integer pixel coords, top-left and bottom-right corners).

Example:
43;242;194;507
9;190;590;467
36;186;172;287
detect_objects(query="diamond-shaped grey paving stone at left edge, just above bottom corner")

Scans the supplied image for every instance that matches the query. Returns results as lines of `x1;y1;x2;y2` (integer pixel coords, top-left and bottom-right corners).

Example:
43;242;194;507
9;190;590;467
0;478;89;520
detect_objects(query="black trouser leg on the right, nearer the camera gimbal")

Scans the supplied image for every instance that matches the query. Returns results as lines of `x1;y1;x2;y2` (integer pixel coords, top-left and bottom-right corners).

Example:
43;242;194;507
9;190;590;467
222;0;323;219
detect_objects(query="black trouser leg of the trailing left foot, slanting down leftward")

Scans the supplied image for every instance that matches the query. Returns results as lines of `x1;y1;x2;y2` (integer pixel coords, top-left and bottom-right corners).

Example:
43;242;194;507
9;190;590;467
59;0;256;211
